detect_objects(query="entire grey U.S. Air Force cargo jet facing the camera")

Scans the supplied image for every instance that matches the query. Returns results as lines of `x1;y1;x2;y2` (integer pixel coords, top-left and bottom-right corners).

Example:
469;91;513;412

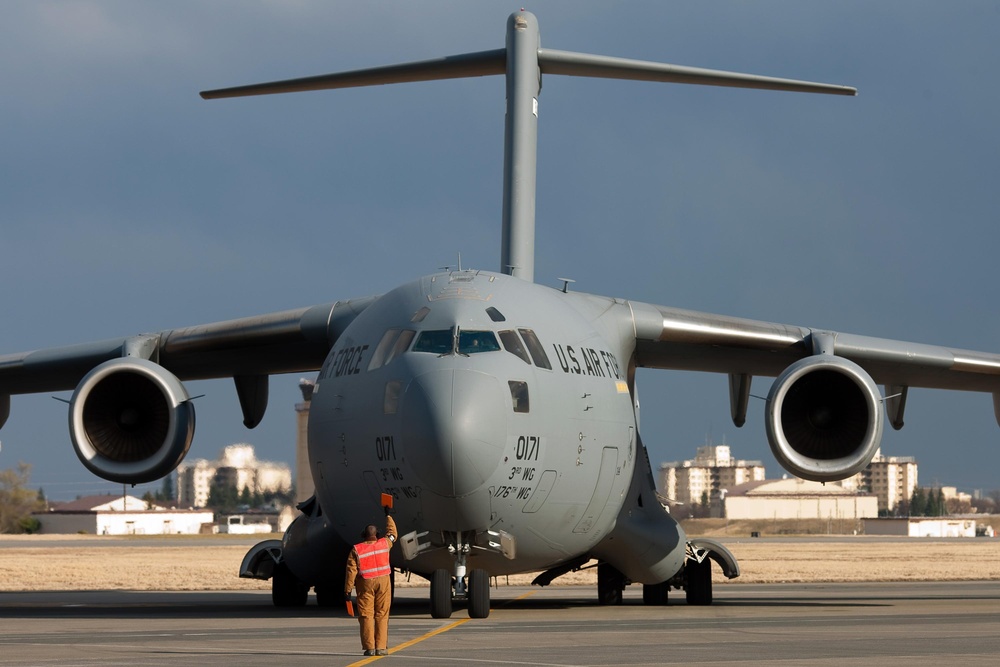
0;11;1000;617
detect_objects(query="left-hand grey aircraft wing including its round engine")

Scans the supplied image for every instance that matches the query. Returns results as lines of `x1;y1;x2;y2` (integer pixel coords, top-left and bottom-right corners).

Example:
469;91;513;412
0;297;377;484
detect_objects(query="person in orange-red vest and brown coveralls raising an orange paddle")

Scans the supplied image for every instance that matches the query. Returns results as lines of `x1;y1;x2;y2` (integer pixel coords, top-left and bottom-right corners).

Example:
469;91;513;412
344;507;396;655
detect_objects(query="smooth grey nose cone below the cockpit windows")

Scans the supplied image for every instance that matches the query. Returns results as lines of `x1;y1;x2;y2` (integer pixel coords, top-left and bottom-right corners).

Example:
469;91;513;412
401;369;507;498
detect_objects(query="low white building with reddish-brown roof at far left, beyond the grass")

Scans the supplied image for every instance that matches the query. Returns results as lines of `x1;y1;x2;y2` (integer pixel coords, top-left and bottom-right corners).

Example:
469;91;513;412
32;495;214;535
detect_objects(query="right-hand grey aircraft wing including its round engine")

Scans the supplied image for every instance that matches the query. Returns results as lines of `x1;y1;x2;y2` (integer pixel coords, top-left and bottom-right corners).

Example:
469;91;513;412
629;303;1000;482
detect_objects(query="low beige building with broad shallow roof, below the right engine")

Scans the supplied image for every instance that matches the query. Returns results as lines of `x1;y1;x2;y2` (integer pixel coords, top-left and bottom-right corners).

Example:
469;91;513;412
722;477;878;519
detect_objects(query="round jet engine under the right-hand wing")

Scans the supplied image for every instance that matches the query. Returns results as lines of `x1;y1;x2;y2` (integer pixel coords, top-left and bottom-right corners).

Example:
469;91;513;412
765;355;883;482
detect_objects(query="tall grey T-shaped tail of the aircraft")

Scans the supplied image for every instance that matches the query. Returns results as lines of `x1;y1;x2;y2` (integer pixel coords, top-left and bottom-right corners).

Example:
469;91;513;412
201;9;857;282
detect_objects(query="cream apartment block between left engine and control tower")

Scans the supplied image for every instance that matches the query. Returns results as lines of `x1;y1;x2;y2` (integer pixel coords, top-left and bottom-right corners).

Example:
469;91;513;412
177;443;292;507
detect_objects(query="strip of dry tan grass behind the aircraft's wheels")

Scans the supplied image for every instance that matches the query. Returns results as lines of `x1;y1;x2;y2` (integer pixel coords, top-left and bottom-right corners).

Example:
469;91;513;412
0;531;1000;591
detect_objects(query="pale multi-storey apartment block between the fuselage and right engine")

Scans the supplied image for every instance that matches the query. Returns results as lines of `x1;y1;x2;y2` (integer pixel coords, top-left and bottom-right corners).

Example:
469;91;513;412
660;445;764;506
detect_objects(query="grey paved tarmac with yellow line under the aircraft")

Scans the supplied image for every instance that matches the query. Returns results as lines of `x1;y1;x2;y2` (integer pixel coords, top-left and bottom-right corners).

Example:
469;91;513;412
0;581;1000;667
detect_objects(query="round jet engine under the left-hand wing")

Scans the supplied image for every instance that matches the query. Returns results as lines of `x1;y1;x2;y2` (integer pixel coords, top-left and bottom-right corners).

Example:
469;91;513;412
69;357;194;484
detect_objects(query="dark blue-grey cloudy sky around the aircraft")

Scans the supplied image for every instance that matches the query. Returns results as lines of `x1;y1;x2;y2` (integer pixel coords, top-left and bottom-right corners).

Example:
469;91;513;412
0;0;1000;498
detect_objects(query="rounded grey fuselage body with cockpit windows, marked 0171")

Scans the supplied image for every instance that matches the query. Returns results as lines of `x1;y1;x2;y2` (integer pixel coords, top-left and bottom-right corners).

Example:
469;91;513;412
309;271;664;575
